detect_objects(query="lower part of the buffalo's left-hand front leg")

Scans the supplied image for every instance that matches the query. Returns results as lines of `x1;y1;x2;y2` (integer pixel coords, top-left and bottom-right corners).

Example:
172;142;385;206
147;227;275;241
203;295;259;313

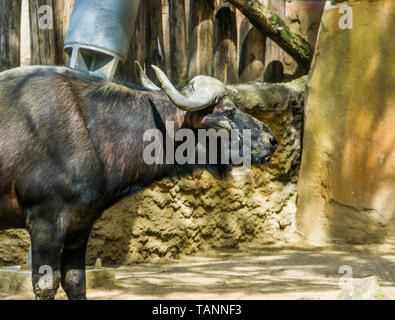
30;219;65;300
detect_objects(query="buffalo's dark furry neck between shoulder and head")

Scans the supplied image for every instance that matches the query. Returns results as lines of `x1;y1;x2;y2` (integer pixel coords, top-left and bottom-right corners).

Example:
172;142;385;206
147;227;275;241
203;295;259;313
79;83;190;197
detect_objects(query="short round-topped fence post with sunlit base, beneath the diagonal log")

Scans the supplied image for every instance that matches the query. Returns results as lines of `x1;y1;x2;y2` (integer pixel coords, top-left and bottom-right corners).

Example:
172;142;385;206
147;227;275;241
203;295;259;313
239;22;266;82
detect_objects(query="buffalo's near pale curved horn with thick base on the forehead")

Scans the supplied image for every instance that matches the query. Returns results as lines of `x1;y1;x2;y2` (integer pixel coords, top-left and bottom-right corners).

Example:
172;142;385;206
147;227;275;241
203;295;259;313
152;65;226;111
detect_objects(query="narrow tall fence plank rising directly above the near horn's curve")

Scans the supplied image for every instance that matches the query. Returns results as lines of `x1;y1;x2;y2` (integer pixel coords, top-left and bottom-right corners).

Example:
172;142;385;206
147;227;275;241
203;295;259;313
169;0;188;85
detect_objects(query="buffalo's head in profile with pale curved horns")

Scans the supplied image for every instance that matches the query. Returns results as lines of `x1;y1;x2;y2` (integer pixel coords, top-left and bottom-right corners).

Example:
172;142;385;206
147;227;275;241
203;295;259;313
140;66;277;168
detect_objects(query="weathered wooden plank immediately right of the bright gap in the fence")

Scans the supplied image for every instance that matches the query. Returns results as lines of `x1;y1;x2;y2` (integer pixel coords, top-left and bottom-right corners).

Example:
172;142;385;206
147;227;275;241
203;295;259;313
30;0;56;65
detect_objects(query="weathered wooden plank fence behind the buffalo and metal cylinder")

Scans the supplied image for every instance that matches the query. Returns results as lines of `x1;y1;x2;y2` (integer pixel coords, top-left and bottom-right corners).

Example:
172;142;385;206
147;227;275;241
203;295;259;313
0;0;290;84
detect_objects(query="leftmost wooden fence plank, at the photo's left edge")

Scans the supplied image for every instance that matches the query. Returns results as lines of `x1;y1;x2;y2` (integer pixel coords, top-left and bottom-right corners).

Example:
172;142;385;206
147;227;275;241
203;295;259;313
0;0;21;72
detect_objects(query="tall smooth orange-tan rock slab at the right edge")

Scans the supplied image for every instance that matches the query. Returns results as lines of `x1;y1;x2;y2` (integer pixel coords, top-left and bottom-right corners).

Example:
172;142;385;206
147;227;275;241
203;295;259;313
297;0;395;243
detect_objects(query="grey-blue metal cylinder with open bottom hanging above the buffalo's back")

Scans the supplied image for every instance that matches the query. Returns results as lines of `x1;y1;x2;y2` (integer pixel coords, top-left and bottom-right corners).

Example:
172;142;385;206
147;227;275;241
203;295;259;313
64;0;141;78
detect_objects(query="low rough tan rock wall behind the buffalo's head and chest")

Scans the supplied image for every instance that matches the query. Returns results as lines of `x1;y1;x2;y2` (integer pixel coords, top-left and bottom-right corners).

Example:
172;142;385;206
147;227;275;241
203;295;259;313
0;80;304;265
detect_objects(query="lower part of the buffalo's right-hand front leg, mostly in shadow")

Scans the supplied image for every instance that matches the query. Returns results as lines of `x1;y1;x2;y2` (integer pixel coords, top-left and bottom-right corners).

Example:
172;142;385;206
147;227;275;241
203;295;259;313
61;233;89;300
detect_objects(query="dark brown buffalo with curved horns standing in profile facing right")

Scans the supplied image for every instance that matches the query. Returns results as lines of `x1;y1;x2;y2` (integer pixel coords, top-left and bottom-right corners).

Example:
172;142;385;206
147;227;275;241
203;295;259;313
0;66;277;299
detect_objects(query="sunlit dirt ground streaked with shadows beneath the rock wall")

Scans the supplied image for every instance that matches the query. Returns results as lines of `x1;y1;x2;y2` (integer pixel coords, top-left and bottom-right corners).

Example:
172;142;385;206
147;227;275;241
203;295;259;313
0;244;395;300
